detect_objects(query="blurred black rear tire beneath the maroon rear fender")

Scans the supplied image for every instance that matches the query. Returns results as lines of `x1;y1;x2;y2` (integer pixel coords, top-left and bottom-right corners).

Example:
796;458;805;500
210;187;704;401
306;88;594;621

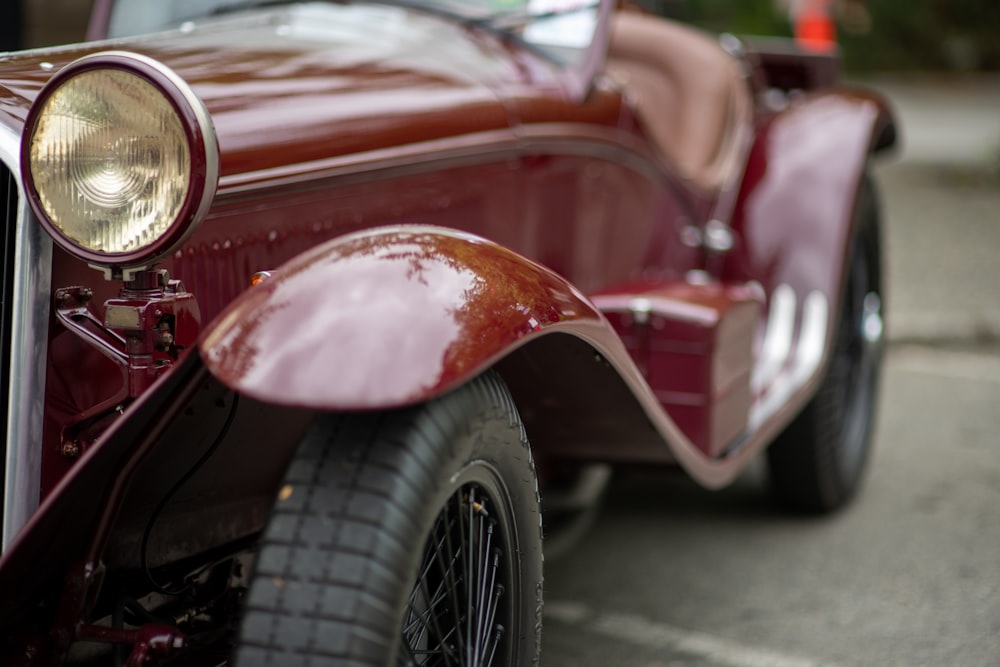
767;177;884;513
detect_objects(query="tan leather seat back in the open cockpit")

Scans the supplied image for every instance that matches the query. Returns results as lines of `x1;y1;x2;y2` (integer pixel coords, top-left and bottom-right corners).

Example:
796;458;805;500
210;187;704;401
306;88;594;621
608;11;753;189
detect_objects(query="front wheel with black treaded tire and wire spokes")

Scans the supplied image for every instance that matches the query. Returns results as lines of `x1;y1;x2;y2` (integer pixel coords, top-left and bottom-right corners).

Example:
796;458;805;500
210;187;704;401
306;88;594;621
236;373;542;667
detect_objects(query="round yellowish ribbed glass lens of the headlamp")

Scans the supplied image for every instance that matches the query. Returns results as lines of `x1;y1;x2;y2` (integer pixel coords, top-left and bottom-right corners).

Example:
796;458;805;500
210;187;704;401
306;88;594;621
30;69;191;255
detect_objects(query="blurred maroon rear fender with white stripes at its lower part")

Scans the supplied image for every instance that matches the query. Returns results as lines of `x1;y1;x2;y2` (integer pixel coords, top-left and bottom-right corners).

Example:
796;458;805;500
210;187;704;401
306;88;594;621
722;90;896;437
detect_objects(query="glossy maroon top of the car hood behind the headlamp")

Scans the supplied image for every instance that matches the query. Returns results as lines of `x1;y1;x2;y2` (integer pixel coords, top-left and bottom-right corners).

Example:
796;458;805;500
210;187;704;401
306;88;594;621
0;4;537;177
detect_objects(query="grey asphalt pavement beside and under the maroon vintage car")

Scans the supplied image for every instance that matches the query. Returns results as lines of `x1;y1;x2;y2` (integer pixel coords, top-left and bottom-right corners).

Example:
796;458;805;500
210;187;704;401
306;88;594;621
542;79;1000;667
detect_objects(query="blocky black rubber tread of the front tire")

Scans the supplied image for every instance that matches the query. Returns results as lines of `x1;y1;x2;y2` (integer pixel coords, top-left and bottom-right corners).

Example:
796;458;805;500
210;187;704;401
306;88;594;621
237;373;541;667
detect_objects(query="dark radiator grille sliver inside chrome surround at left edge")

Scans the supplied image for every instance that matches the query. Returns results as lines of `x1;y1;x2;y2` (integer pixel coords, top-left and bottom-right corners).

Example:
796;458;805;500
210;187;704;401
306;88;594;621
0;162;18;496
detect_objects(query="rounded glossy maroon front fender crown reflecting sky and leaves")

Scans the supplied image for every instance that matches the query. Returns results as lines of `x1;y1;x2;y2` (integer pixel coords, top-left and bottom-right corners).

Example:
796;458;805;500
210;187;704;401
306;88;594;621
202;226;610;410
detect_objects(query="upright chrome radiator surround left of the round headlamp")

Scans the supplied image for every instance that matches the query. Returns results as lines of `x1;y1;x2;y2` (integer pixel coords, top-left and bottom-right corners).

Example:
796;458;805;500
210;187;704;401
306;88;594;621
0;127;52;549
